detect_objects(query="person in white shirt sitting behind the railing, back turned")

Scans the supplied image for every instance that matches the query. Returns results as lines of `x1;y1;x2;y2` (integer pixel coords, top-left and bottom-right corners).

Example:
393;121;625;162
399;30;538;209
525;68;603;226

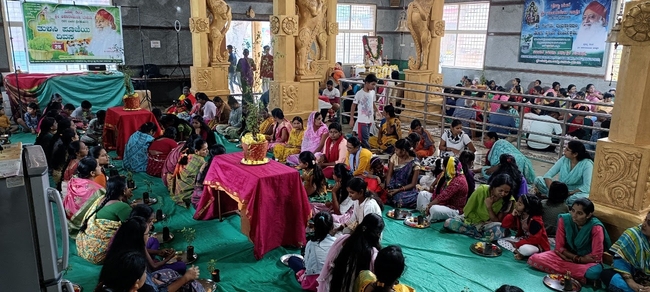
526;112;562;152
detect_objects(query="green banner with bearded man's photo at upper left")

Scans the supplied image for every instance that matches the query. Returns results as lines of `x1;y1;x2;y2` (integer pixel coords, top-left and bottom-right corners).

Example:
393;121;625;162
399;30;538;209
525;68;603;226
22;2;124;63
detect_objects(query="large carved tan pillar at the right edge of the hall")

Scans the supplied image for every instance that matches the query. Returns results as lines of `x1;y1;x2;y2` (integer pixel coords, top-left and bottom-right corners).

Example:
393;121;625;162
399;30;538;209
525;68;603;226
589;1;650;238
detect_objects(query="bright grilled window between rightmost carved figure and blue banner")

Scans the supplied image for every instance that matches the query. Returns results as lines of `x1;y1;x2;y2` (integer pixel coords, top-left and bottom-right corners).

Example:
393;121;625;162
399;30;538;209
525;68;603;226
440;2;490;69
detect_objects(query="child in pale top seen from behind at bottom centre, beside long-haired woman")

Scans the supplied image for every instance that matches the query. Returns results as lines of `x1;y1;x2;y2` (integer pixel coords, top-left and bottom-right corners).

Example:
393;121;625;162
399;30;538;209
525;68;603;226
288;212;336;291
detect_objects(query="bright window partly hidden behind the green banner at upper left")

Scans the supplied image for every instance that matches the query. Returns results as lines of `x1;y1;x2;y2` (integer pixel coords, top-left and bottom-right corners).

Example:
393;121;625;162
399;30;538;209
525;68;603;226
2;0;117;73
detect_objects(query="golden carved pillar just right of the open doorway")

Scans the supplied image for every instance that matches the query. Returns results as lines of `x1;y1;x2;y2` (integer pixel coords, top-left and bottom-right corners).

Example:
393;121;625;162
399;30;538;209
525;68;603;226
269;0;338;118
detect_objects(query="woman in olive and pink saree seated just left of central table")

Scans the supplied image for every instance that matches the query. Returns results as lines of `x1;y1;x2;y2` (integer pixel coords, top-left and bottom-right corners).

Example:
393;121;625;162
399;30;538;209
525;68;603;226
167;139;208;208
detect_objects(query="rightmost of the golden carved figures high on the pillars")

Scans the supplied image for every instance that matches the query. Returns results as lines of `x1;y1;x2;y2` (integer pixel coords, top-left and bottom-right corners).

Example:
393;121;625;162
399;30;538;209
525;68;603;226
406;0;433;70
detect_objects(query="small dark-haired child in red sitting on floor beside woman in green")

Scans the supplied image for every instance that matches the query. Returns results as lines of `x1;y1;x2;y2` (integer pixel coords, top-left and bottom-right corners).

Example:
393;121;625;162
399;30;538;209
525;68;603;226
498;194;551;260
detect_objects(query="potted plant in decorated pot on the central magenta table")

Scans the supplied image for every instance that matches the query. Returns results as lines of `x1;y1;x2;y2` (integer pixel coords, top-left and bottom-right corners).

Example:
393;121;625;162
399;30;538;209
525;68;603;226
241;100;269;165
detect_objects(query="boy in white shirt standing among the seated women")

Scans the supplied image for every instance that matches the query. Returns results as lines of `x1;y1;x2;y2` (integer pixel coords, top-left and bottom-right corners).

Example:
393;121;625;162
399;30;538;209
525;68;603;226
350;73;377;149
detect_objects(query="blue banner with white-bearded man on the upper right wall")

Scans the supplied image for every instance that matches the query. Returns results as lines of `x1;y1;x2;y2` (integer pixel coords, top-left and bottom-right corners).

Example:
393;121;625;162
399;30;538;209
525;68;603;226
519;0;611;67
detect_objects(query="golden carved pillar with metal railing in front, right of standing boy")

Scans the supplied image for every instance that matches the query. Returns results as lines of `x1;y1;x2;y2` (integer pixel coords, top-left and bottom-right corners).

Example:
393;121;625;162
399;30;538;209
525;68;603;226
403;0;445;121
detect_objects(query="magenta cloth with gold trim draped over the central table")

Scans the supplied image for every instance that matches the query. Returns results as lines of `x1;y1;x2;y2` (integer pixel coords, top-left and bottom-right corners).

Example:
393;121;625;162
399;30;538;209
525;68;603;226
204;152;311;259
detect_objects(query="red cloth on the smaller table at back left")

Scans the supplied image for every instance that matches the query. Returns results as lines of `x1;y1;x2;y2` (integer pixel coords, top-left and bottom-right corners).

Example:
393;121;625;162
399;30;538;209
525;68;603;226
103;106;160;159
